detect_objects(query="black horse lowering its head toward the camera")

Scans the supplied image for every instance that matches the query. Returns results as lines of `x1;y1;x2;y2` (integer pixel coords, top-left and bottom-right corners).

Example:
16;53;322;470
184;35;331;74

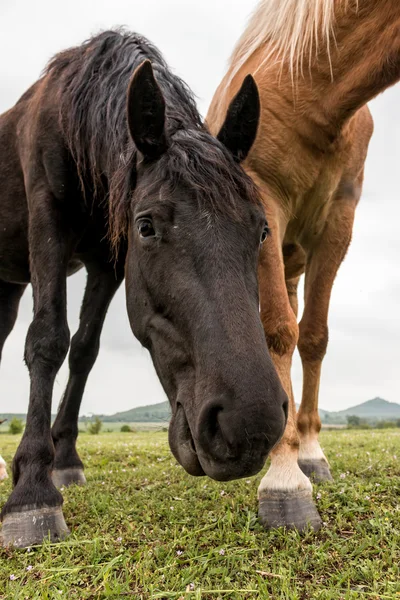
0;31;287;546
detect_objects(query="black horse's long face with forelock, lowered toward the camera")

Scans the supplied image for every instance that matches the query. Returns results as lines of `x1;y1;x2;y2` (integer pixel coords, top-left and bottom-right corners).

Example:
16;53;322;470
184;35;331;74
126;66;287;480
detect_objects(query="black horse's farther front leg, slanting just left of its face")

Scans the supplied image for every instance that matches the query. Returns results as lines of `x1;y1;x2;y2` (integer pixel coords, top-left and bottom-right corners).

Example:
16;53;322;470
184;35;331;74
52;264;124;487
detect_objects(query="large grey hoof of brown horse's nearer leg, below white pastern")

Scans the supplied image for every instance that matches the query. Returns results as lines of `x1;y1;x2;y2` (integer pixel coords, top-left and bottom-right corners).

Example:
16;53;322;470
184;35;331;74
258;490;322;532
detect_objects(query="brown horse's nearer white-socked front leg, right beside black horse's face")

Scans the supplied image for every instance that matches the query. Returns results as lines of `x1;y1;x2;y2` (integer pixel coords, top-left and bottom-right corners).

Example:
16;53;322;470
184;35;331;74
258;197;321;530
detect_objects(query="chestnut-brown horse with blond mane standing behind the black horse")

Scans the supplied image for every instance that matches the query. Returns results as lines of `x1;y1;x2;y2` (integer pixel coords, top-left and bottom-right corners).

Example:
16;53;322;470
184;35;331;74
206;0;400;529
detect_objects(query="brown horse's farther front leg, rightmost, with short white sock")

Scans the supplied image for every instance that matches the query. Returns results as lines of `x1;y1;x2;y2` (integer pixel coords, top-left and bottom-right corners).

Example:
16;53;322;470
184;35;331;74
297;197;357;481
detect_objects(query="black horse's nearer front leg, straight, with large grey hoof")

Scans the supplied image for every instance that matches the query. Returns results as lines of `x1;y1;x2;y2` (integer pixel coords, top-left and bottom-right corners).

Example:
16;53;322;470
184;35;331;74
2;195;75;547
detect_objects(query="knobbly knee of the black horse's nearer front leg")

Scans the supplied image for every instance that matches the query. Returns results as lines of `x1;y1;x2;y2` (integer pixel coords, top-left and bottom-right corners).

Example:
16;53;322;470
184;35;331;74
25;314;69;371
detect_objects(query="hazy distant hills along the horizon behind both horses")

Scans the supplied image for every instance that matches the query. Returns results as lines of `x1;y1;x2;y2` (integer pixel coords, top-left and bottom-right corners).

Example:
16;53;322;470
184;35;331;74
0;398;400;428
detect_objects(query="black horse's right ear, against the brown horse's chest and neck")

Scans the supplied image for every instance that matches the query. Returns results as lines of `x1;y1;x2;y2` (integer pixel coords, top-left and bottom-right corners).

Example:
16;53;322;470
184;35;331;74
217;75;260;162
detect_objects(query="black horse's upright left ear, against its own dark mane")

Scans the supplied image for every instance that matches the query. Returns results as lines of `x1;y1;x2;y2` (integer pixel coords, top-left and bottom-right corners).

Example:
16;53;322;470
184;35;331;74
127;60;167;160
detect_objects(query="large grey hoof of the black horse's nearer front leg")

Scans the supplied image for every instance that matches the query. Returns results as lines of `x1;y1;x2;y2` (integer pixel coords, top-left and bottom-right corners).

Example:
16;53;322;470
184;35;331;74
1;506;69;548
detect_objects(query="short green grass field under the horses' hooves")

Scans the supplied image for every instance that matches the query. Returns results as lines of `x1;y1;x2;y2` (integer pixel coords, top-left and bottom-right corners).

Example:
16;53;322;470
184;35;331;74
0;429;400;600
